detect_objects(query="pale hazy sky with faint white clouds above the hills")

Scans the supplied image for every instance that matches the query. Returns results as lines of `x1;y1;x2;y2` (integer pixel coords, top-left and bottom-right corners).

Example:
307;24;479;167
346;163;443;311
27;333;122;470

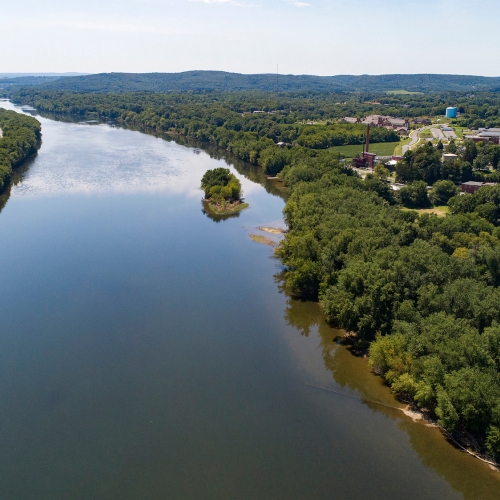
0;0;500;76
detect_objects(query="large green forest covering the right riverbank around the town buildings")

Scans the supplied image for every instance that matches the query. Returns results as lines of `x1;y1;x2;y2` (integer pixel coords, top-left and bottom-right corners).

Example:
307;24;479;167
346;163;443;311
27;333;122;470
12;89;500;460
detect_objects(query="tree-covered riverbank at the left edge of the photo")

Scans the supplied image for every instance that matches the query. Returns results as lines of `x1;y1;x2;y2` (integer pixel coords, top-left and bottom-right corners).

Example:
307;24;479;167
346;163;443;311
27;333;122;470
0;109;41;189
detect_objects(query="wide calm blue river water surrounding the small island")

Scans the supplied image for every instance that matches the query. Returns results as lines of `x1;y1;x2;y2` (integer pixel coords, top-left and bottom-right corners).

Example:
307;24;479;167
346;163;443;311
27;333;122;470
0;102;500;500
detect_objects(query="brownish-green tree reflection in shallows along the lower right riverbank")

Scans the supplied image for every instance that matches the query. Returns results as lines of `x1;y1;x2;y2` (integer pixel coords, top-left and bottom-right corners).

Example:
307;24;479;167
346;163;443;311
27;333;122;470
285;298;500;500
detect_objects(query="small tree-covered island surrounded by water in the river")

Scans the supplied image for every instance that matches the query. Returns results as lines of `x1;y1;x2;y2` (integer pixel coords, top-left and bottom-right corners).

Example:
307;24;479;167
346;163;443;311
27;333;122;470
201;168;248;215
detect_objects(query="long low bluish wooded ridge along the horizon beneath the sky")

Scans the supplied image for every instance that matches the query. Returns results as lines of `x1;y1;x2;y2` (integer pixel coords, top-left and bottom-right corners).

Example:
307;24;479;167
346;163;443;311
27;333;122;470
28;71;500;92
